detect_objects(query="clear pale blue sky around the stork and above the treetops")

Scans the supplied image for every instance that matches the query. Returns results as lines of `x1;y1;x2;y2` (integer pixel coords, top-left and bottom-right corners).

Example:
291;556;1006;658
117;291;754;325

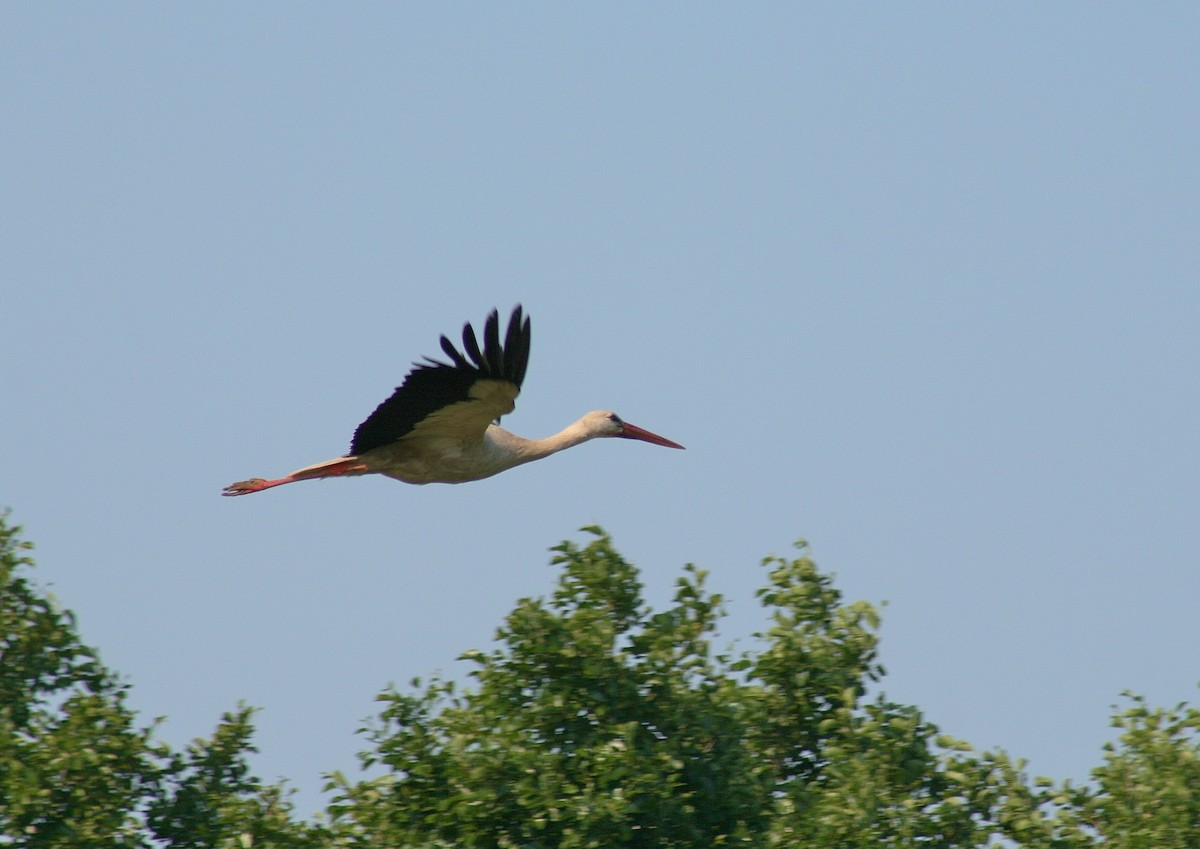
0;2;1200;814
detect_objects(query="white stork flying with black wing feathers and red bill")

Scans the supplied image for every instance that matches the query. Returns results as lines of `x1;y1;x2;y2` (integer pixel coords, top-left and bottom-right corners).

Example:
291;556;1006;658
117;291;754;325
222;305;683;495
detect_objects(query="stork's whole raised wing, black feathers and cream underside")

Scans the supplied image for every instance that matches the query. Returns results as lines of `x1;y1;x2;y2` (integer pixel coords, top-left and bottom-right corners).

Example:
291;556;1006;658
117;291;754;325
350;303;529;454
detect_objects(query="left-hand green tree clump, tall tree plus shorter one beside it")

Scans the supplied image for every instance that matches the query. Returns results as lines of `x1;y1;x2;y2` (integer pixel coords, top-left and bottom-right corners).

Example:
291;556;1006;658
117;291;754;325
0;513;323;849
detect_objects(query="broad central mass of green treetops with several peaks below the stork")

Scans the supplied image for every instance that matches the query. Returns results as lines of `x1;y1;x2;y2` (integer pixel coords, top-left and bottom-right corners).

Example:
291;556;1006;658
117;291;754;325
331;529;1008;849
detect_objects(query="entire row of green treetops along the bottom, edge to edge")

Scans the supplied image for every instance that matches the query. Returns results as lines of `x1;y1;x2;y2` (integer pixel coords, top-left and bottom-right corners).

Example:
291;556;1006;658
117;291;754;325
0;516;1200;849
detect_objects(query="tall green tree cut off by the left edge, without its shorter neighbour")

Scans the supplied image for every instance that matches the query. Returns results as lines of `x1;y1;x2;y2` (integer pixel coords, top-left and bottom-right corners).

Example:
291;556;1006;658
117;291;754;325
0;516;158;847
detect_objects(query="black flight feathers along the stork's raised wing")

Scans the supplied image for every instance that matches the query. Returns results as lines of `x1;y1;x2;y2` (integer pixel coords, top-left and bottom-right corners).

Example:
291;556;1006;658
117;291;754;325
350;303;530;454
